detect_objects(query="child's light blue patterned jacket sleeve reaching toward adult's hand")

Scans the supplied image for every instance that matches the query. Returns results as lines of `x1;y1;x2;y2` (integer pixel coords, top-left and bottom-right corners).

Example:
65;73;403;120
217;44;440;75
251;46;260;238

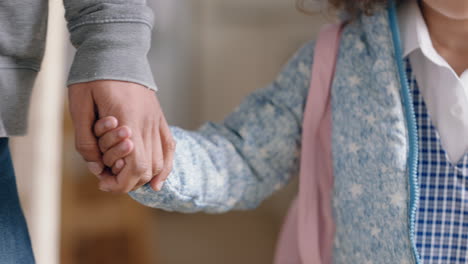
130;39;314;213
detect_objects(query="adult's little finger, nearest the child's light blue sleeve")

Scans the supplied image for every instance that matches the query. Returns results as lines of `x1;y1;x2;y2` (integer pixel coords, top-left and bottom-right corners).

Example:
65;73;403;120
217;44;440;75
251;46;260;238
150;117;176;191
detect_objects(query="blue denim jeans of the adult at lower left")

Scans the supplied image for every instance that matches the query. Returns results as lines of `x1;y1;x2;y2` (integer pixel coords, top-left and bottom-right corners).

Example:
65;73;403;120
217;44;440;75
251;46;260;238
0;138;34;264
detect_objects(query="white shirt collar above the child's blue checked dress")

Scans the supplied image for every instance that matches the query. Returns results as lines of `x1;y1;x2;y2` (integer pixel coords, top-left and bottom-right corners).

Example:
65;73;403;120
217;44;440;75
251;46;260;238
398;0;468;162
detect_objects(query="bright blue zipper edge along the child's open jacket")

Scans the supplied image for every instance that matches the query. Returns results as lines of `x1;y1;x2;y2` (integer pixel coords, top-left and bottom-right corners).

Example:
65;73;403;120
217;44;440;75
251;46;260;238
388;1;421;264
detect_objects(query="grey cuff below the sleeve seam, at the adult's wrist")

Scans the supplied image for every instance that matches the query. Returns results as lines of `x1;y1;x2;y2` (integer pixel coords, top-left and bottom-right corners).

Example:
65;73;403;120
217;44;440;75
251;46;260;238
67;20;157;90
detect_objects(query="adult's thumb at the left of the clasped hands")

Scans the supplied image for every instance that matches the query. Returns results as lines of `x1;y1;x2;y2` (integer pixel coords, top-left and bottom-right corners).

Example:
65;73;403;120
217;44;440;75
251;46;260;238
68;84;104;175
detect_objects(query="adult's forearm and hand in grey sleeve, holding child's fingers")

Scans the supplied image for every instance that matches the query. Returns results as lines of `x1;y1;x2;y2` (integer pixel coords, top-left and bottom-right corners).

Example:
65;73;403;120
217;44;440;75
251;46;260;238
64;0;174;192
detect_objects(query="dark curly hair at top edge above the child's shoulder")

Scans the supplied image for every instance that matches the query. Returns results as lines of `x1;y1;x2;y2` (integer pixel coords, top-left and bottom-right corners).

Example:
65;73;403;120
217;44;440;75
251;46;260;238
297;0;399;16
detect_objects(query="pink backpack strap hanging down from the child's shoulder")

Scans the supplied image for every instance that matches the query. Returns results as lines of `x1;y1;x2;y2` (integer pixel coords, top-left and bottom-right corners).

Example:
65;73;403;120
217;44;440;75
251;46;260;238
298;25;342;264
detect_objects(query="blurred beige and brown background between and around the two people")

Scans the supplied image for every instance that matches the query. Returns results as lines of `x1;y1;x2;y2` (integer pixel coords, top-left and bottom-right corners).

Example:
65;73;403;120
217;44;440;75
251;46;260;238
12;0;330;264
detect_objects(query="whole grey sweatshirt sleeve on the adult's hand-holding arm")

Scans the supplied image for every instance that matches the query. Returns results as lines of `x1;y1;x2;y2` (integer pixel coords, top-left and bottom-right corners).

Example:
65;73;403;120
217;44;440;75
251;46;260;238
63;0;156;90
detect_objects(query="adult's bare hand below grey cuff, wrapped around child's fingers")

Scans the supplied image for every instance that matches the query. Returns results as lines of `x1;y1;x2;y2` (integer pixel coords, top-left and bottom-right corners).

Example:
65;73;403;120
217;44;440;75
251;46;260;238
69;80;175;193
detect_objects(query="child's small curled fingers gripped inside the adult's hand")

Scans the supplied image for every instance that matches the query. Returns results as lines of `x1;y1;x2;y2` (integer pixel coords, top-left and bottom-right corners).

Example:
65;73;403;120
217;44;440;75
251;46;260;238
94;116;134;175
